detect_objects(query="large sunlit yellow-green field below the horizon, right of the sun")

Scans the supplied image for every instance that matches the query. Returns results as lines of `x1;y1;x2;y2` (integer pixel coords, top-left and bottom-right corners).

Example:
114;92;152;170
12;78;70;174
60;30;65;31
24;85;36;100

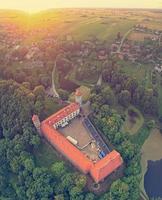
71;16;136;42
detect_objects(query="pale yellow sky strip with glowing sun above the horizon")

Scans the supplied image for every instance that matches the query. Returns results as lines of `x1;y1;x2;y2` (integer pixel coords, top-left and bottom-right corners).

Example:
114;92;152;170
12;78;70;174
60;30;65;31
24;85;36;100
0;0;162;12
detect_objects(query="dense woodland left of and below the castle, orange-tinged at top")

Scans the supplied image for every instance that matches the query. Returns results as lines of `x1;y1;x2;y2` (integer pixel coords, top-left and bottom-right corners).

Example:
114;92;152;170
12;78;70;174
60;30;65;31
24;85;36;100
0;81;95;200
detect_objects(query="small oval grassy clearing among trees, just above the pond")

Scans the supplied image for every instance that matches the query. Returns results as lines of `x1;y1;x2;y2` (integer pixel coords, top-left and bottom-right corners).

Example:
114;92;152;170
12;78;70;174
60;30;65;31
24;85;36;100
122;106;144;135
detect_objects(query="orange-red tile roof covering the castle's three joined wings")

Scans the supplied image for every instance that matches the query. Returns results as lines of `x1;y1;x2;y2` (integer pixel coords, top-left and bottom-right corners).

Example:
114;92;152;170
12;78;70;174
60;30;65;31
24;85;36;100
41;103;123;183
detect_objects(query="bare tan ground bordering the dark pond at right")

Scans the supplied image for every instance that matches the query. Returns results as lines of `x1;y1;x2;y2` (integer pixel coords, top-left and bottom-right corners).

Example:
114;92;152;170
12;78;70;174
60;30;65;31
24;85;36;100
140;129;162;197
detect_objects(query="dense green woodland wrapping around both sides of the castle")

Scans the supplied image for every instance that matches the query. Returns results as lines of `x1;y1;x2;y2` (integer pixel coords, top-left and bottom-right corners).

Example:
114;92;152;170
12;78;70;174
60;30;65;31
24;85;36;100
0;80;154;200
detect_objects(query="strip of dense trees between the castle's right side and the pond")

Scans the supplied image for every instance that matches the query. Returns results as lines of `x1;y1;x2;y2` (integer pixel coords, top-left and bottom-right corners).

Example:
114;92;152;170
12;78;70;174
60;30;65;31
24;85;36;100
91;87;154;200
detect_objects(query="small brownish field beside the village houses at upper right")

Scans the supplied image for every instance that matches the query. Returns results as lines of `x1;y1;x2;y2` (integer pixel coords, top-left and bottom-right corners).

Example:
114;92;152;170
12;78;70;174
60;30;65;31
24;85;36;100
128;32;154;42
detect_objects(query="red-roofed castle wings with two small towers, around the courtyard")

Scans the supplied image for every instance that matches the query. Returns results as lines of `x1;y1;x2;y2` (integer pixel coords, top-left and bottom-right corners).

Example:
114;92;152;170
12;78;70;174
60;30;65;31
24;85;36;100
32;92;123;183
